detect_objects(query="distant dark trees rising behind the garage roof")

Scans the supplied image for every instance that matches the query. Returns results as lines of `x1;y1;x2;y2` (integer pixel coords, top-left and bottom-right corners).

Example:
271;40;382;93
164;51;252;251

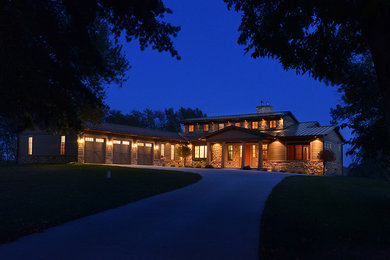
105;107;206;132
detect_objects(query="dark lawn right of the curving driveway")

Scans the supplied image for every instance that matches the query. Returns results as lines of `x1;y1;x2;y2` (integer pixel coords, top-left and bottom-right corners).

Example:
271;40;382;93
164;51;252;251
259;176;390;259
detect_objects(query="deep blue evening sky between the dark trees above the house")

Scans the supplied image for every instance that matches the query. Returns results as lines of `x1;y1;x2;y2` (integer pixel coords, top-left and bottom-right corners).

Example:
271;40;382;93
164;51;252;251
106;0;350;164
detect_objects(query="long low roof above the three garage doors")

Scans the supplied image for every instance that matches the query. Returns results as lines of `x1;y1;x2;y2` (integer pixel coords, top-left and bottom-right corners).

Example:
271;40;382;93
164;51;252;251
86;122;186;140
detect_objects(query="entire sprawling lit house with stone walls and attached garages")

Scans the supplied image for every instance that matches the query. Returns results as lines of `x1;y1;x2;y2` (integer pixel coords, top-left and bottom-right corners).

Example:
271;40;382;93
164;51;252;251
18;106;344;175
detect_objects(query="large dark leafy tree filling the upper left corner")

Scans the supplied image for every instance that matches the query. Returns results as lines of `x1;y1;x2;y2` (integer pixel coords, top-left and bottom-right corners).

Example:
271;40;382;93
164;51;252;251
0;0;180;130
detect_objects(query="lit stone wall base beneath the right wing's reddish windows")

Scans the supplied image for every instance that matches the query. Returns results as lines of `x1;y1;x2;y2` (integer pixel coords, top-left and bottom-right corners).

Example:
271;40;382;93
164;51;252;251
263;161;324;175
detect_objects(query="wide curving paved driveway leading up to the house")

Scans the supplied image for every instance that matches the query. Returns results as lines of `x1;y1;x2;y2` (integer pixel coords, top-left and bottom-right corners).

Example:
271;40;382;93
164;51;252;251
0;167;287;259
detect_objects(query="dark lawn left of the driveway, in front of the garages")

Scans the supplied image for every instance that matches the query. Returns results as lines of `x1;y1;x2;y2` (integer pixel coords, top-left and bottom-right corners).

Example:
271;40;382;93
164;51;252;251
0;164;201;243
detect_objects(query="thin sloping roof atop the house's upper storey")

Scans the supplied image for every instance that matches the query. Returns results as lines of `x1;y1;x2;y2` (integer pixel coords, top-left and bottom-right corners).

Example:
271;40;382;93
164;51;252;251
181;111;298;123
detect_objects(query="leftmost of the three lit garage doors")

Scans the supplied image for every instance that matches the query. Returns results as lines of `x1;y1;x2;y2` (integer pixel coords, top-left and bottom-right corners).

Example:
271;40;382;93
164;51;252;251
85;137;106;163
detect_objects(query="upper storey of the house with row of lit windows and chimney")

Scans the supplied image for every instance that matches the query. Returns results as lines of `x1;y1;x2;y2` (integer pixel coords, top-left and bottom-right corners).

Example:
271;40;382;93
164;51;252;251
181;105;299;137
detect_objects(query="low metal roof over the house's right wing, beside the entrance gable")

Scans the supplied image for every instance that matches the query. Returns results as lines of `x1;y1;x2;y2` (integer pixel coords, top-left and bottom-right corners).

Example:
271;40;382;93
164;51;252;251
265;122;345;141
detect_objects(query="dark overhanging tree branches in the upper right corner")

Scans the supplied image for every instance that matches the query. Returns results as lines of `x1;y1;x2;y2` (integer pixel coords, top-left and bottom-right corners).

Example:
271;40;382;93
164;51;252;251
224;0;390;138
